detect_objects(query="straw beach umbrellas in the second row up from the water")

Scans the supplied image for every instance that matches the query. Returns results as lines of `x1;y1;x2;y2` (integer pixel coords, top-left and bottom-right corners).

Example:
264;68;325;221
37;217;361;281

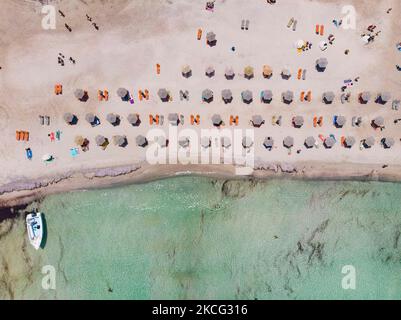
64;112;384;129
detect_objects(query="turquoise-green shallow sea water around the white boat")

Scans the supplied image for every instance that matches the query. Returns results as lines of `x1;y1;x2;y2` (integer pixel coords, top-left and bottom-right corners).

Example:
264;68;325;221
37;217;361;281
0;177;401;299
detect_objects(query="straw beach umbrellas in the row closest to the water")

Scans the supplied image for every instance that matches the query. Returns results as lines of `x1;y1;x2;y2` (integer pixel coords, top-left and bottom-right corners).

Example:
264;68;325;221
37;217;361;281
95;135;395;150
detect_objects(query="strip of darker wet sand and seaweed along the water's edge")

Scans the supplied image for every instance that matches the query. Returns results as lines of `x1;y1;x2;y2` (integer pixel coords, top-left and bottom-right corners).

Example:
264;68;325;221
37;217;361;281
0;162;401;212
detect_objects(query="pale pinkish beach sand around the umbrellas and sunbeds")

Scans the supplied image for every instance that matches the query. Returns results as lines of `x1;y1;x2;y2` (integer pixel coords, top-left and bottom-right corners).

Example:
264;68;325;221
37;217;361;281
0;0;401;208
